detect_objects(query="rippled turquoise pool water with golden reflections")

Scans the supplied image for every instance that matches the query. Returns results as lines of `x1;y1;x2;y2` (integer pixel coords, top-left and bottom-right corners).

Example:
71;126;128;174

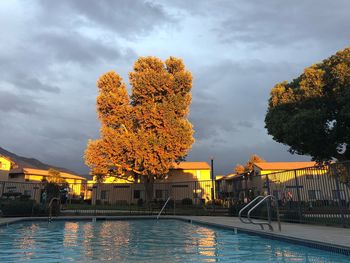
0;220;350;263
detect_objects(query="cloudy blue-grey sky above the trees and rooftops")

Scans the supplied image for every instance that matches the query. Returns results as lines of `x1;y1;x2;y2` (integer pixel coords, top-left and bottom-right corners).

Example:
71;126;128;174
0;0;350;174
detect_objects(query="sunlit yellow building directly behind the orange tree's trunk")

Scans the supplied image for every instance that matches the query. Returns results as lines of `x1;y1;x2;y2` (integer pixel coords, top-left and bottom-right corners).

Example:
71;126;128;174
87;162;213;204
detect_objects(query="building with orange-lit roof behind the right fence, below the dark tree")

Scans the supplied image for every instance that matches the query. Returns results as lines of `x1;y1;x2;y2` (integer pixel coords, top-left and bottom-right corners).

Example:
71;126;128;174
250;162;350;204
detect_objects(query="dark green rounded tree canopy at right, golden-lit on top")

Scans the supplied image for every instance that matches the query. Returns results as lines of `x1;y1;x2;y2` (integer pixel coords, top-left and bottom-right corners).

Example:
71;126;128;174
265;48;350;162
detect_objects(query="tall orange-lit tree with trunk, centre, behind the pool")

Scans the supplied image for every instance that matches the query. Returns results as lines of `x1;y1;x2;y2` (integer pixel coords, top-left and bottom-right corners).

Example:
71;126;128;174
85;57;194;202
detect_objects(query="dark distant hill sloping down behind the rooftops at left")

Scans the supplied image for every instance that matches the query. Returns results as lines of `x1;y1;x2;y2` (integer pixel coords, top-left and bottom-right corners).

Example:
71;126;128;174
0;147;77;174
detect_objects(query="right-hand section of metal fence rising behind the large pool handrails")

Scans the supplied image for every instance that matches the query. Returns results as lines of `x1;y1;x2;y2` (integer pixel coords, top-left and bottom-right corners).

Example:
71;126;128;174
217;162;350;227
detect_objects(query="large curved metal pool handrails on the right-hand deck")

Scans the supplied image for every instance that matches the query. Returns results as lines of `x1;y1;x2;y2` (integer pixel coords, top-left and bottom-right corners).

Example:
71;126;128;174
238;195;281;231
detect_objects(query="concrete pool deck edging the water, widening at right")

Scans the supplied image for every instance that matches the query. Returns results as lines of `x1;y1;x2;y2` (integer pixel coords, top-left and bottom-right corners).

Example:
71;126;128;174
0;216;350;255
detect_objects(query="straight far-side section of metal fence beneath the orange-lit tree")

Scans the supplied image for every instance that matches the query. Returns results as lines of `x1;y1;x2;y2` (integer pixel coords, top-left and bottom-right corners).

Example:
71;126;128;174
0;181;221;216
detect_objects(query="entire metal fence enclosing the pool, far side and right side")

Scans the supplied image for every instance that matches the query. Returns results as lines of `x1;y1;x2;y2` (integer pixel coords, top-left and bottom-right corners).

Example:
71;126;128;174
0;162;350;227
